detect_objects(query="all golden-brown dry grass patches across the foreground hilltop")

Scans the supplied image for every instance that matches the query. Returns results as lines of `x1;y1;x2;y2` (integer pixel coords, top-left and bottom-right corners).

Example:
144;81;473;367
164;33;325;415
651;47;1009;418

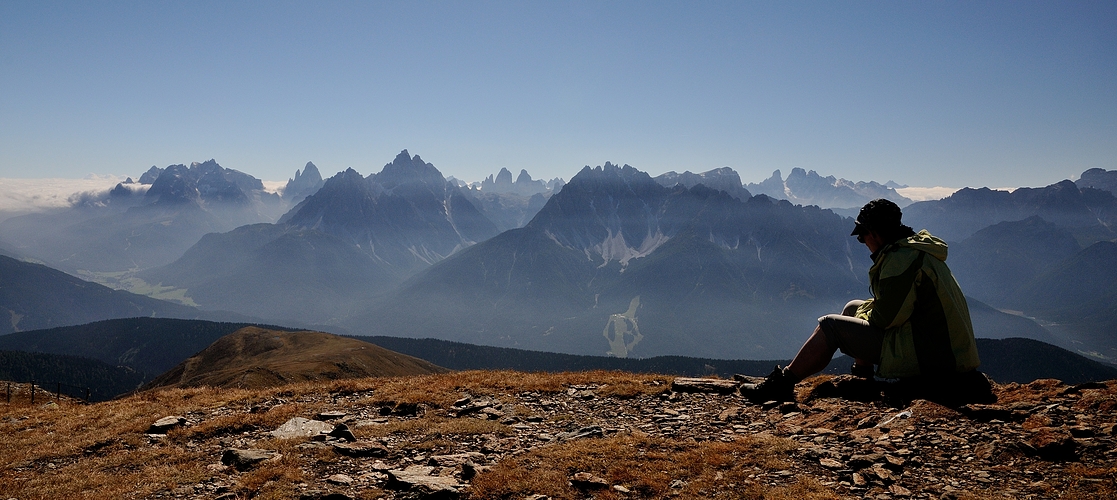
0;372;1114;500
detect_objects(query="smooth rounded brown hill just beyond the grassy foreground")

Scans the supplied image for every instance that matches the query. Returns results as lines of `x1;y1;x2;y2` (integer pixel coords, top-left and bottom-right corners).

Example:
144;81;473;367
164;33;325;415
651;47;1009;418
143;327;448;390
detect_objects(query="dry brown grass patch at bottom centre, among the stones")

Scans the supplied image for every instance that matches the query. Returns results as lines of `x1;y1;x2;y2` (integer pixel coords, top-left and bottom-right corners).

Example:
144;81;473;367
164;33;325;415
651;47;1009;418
464;435;837;500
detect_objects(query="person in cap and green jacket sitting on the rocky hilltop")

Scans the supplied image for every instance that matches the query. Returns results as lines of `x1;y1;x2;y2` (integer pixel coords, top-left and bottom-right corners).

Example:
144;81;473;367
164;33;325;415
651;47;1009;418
741;199;987;402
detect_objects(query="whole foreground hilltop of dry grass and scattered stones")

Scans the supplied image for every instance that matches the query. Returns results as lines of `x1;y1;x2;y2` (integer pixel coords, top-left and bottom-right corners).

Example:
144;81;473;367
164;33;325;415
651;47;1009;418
0;371;1117;500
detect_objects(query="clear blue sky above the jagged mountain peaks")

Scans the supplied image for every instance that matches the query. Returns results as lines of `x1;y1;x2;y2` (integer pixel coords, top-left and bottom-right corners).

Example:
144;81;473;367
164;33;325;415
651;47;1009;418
0;0;1117;186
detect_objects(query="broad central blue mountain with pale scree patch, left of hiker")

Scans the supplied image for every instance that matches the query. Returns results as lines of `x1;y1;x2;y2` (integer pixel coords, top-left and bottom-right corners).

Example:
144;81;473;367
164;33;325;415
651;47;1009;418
346;164;869;358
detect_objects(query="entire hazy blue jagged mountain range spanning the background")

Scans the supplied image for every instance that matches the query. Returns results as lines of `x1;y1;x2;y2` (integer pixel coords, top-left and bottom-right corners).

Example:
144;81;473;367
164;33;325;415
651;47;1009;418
0;151;1117;366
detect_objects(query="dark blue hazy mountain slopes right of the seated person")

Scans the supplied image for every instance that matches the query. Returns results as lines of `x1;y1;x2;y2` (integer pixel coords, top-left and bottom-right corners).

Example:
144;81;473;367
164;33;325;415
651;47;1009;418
904;179;1117;363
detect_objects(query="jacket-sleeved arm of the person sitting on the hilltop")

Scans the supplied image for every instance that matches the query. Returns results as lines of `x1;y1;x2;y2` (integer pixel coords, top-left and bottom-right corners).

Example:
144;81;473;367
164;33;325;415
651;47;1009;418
865;249;923;329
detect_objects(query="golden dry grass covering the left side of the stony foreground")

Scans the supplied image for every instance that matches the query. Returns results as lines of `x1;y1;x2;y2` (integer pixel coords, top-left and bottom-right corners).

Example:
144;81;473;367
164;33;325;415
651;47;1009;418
0;372;670;500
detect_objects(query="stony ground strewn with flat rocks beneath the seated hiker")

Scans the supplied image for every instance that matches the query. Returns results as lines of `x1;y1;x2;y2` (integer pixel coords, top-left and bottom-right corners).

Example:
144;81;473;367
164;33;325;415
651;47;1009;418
3;376;1117;500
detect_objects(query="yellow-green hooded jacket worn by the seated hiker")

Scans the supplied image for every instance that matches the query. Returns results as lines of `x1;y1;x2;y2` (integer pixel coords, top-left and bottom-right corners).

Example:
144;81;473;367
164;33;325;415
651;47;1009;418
857;230;981;378
